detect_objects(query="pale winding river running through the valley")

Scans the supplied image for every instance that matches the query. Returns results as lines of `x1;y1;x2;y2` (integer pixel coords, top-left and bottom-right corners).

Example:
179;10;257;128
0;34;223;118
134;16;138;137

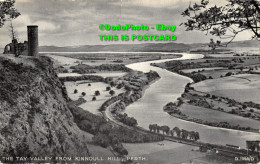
125;53;260;148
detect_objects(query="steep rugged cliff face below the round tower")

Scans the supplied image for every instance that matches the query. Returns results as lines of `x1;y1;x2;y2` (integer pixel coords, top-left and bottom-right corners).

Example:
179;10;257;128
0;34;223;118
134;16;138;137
0;57;89;161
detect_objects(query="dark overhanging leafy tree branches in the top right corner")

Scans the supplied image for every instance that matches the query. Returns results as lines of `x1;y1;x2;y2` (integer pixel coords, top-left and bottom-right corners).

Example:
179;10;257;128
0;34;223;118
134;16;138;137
181;0;260;46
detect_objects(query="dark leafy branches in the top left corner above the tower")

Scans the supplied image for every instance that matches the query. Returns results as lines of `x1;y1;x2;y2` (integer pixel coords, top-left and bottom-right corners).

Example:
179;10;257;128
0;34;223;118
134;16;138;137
0;0;21;28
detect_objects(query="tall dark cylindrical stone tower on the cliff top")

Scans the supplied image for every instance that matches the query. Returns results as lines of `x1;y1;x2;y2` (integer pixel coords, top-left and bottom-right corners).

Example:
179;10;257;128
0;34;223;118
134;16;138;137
27;25;38;56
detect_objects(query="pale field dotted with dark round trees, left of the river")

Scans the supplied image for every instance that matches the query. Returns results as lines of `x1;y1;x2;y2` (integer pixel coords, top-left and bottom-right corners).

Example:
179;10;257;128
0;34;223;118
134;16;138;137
65;81;124;114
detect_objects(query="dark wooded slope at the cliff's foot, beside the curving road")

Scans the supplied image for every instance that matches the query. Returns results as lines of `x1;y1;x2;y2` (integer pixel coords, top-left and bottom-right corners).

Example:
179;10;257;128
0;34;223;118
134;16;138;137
69;101;164;155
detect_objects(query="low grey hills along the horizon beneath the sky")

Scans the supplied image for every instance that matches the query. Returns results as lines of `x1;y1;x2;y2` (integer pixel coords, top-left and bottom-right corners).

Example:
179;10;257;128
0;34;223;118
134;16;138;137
39;40;260;52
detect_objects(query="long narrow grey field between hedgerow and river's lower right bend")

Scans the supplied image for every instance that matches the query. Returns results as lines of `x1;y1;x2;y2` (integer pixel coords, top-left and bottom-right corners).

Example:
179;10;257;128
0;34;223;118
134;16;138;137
179;104;260;129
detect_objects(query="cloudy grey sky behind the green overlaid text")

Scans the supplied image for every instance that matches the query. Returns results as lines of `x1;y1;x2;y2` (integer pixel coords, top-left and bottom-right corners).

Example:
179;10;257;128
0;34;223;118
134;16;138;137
0;0;256;48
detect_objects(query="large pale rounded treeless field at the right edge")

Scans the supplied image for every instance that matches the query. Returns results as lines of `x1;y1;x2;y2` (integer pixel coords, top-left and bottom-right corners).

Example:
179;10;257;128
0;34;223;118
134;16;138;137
192;74;260;103
